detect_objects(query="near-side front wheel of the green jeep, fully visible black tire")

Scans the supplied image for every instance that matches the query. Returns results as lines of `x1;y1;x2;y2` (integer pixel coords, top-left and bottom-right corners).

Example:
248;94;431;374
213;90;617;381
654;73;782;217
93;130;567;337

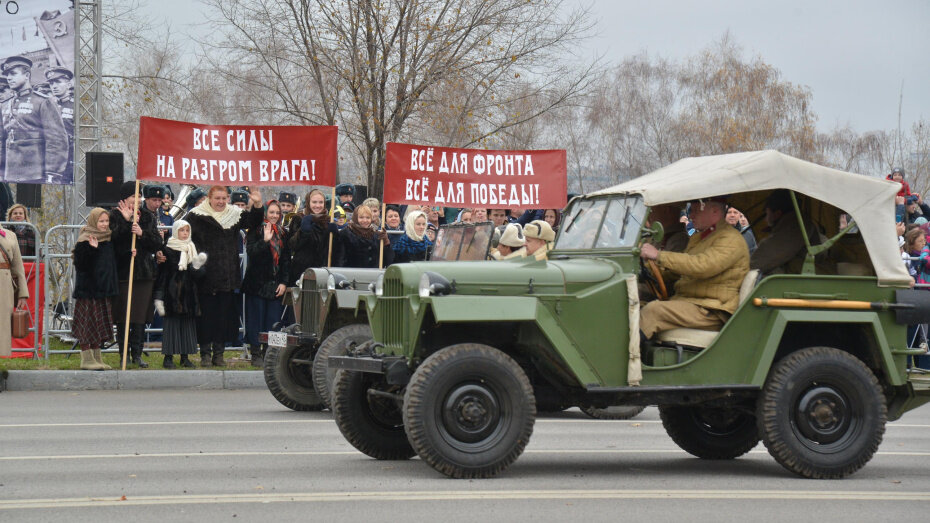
404;343;536;478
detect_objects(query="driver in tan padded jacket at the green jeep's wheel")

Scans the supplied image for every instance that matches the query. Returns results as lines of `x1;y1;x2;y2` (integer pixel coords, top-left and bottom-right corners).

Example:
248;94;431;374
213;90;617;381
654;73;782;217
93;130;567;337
639;198;749;339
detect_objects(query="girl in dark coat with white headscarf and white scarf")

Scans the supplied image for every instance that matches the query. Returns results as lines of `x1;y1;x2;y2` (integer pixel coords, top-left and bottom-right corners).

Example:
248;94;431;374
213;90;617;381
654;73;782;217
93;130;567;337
154;220;207;369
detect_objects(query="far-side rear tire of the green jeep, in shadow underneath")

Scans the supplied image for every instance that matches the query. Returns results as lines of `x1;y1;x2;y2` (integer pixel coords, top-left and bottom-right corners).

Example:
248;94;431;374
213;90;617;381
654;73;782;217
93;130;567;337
659;405;759;459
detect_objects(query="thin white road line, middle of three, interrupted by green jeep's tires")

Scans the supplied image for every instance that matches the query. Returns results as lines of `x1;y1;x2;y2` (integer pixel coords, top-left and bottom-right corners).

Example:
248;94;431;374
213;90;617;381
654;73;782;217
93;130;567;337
0;449;930;461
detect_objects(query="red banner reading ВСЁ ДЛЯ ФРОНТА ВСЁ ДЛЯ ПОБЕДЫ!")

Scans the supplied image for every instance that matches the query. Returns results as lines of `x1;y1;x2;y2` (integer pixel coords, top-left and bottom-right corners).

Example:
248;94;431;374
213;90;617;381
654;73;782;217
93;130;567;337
384;143;568;209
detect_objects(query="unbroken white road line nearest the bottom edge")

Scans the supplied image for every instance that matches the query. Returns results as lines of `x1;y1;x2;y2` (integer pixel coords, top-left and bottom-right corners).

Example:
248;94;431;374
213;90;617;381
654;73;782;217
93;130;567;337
0;490;930;510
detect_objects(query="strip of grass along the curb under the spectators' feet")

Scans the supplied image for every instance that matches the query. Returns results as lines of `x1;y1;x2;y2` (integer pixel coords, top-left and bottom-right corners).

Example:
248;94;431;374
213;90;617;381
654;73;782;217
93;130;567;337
0;338;258;372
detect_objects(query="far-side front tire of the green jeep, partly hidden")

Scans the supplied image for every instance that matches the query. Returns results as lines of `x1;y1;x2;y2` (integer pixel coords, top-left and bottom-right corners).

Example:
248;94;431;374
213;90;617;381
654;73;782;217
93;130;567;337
333;370;416;460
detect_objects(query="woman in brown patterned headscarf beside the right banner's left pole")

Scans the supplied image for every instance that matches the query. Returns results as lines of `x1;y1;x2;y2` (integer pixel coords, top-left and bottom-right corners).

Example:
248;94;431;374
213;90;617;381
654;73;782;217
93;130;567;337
333;205;394;269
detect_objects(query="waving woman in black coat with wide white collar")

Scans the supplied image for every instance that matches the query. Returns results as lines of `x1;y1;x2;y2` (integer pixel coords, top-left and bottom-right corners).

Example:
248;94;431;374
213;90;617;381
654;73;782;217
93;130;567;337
185;185;264;367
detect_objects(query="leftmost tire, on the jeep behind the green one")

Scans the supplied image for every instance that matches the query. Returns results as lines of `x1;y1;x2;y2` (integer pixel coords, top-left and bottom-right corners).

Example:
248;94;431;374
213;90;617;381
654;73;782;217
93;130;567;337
263;346;323;411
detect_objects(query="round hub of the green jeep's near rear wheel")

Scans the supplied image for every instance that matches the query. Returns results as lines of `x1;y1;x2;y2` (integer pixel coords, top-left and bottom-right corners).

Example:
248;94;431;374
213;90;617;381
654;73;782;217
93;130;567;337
795;385;850;444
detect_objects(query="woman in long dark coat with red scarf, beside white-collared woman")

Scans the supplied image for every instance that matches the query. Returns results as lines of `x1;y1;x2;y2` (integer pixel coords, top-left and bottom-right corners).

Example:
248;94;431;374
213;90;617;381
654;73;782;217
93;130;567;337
242;201;292;367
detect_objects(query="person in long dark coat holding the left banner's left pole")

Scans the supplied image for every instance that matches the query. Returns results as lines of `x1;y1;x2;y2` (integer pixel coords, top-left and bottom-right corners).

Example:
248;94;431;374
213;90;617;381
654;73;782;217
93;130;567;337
110;182;163;368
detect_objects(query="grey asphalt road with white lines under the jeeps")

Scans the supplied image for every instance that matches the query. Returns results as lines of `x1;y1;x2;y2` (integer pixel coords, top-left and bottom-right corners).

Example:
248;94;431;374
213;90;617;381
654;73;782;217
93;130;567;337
0;390;930;523
